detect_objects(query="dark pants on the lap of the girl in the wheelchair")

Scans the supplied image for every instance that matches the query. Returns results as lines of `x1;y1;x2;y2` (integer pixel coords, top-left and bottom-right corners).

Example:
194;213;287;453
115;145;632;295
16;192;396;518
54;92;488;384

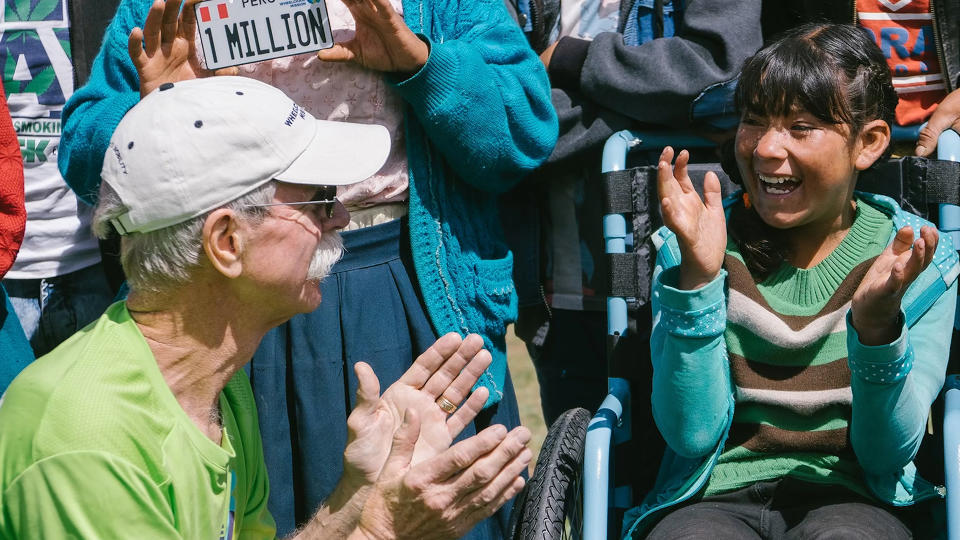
647;478;912;540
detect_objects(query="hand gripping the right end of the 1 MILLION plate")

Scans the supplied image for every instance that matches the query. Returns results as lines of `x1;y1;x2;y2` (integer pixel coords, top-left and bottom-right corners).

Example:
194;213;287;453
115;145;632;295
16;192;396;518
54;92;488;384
317;0;430;73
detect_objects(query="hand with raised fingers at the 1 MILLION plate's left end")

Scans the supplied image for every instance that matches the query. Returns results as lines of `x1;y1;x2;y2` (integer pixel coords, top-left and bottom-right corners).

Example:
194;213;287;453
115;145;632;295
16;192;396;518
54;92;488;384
127;0;236;97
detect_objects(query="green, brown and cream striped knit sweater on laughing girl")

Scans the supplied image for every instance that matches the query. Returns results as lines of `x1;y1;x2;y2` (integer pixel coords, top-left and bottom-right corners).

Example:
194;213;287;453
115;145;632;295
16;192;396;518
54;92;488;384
707;204;892;494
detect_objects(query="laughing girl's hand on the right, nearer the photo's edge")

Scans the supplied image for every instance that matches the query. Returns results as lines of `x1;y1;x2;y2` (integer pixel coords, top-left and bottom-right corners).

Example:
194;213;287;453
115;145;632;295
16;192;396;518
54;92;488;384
850;226;939;345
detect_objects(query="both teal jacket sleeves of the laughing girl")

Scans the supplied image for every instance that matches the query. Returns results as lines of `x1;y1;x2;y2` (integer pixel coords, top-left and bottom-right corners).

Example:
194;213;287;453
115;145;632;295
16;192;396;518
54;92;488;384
651;196;957;487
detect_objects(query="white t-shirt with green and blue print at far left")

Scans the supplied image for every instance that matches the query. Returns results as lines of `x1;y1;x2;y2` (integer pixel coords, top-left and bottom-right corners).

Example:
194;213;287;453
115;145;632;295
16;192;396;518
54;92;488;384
0;0;100;279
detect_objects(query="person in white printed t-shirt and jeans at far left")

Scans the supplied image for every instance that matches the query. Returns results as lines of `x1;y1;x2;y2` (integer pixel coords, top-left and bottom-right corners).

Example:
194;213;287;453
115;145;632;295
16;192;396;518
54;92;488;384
0;0;113;356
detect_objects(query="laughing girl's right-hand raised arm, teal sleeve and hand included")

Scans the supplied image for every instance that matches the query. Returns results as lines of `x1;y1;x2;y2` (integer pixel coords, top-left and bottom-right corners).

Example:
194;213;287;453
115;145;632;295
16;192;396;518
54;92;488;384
847;227;957;474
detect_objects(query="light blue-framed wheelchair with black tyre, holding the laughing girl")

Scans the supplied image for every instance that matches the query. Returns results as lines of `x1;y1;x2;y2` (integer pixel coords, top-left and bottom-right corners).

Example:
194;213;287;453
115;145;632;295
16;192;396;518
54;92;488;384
511;127;960;540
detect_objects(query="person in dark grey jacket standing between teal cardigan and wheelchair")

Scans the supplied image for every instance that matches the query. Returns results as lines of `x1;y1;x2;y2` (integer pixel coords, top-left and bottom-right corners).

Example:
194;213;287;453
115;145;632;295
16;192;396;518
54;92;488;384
503;0;762;425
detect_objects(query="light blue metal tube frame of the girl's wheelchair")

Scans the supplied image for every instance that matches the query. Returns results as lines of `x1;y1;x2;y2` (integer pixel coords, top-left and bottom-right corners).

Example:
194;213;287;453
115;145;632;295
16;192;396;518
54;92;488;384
583;127;960;540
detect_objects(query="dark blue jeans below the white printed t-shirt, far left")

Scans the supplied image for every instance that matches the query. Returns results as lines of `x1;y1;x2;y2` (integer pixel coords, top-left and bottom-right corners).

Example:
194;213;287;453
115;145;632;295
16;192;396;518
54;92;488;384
3;263;113;357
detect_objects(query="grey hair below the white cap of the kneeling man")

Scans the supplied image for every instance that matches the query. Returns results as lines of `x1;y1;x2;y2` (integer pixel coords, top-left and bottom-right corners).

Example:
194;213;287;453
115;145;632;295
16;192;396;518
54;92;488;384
92;181;277;292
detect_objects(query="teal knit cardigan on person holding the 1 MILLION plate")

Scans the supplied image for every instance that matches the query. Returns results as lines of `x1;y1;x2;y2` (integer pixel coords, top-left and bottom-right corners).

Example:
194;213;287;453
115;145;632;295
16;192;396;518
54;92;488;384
58;0;558;404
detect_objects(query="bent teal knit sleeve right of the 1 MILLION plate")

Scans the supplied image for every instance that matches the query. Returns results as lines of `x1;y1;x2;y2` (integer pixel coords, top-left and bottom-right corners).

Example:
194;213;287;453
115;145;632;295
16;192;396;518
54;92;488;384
386;0;557;192
